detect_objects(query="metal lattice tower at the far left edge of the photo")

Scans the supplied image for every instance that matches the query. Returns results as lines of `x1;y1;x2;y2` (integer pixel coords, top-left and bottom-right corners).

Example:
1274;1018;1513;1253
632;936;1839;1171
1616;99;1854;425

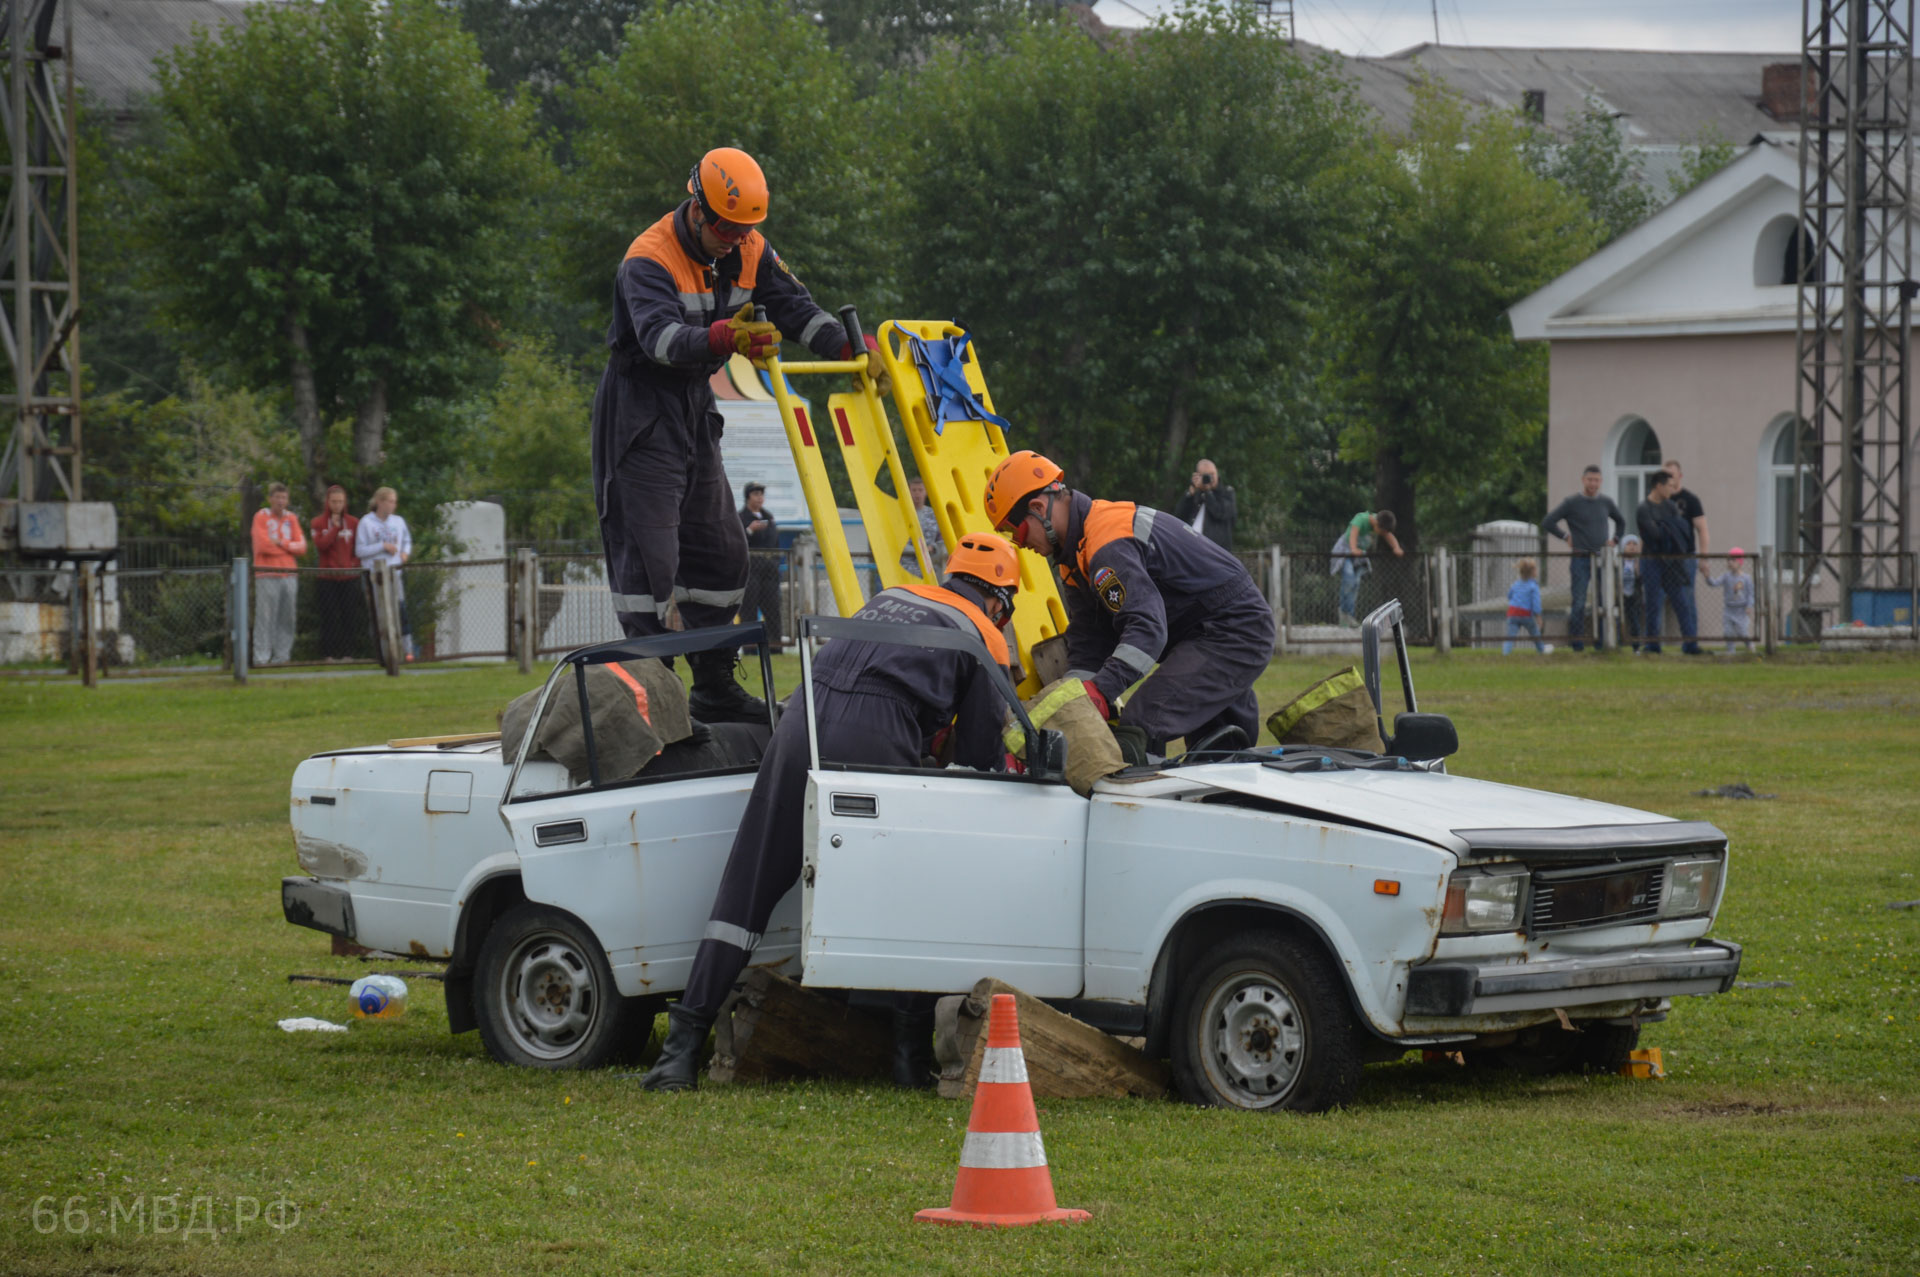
0;0;81;501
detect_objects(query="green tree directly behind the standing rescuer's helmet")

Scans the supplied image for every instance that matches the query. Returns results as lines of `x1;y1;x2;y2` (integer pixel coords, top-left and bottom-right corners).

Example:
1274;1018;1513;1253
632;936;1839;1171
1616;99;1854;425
559;0;895;325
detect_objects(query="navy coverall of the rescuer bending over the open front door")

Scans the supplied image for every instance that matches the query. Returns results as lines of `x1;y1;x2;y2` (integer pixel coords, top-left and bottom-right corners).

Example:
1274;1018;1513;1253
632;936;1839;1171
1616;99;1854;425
680;578;1008;1024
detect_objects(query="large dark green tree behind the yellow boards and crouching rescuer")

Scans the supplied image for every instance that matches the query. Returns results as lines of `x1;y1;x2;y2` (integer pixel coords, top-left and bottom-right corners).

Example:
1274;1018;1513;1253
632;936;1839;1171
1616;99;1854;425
900;6;1361;505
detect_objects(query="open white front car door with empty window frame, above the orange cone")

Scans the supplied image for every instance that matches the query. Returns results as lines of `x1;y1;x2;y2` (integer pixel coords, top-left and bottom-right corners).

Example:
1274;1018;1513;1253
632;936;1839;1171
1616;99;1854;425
801;616;1091;997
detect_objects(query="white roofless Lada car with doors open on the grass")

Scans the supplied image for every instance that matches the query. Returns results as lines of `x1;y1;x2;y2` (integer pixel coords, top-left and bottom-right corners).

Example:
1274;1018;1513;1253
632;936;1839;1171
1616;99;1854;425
280;603;1740;1110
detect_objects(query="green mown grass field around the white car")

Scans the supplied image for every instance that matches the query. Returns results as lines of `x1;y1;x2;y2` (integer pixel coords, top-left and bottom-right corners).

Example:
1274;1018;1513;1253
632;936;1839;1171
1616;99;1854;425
0;653;1920;1275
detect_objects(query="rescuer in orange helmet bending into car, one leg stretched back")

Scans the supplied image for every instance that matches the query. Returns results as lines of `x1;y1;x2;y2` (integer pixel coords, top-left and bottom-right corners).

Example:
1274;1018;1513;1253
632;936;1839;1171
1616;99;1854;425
641;532;1020;1091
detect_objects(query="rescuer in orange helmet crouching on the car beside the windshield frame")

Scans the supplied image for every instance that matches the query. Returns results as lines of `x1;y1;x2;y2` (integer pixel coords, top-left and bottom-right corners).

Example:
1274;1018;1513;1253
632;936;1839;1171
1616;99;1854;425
985;449;1273;753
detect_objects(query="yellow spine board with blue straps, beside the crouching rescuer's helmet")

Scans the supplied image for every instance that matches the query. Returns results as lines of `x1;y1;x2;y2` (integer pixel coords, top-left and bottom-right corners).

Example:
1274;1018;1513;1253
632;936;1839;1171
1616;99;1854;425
875;319;1068;697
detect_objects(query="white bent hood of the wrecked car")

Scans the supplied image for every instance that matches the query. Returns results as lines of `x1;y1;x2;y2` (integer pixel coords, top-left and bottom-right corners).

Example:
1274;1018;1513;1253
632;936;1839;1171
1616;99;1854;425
1179;762;1674;855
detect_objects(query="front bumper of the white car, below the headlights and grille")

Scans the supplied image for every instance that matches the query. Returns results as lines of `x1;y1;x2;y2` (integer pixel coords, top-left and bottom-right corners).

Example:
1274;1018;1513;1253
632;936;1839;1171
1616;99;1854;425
1405;939;1740;1018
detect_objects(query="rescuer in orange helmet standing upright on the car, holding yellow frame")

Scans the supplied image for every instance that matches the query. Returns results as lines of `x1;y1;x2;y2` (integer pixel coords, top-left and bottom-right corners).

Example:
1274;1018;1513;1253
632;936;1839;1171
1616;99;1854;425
593;146;872;722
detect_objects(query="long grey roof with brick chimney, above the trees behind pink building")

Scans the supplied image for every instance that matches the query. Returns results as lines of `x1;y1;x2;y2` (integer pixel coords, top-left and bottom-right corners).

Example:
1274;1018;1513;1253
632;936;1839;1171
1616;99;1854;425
1336;44;1799;144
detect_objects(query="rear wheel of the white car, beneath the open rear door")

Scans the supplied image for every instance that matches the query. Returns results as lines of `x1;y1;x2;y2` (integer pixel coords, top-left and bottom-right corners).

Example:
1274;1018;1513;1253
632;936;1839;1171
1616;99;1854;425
474;904;657;1070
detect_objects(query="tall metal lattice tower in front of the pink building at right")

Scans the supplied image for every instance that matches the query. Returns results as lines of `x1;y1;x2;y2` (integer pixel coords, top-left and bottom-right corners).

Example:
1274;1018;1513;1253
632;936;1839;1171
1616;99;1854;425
1795;0;1914;605
